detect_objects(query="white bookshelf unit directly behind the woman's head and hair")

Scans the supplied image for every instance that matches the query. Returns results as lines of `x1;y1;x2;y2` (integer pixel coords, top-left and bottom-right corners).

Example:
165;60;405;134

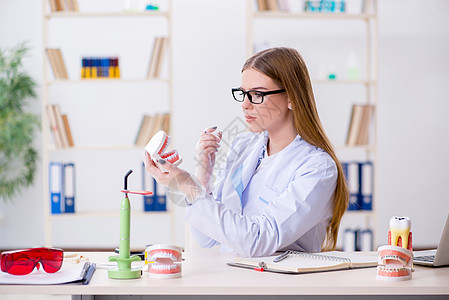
246;0;378;250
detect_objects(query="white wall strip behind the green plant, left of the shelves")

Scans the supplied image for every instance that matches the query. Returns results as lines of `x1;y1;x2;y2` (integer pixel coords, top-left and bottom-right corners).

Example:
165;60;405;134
0;1;44;249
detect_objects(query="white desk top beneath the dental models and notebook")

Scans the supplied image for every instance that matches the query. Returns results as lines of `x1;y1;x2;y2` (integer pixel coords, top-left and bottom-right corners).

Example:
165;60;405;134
0;251;449;295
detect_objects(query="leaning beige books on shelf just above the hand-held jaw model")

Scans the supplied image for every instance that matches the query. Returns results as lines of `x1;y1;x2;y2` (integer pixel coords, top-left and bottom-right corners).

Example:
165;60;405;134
136;114;170;147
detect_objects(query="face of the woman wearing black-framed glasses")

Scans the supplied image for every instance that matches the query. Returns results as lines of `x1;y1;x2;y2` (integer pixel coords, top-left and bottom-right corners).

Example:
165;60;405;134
241;68;292;134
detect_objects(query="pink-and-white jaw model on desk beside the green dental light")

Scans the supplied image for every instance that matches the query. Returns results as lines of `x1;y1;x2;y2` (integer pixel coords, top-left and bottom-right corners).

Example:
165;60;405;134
145;245;182;279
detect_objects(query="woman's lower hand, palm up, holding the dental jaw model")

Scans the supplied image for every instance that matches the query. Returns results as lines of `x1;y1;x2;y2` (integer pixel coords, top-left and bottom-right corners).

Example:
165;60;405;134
143;151;204;204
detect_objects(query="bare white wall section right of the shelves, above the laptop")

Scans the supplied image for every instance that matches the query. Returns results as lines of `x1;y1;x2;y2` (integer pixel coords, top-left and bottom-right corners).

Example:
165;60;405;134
378;0;449;246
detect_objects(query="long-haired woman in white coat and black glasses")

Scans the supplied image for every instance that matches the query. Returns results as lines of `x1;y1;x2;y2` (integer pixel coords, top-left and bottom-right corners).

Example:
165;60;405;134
144;48;348;256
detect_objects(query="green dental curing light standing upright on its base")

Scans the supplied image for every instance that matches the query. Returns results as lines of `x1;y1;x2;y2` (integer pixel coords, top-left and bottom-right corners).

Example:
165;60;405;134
108;170;148;279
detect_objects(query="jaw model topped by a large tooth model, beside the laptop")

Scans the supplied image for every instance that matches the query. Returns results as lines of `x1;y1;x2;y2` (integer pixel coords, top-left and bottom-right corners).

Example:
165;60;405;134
377;217;413;280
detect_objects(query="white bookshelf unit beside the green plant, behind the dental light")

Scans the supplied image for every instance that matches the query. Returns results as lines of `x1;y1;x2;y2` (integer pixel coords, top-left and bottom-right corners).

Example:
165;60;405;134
41;0;175;249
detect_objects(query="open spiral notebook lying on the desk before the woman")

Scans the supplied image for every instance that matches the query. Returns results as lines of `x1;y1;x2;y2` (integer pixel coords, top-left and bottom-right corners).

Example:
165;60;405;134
229;251;377;274
